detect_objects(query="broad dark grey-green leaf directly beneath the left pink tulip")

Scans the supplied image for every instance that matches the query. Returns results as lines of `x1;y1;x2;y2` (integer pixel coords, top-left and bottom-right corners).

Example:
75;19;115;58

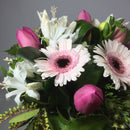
17;47;45;62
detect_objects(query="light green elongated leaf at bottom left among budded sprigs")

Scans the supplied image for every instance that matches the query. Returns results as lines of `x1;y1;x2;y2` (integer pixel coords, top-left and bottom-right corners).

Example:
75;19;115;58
9;109;39;123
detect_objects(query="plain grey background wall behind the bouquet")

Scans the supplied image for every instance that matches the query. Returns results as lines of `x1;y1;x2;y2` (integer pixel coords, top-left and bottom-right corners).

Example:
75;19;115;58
0;0;130;130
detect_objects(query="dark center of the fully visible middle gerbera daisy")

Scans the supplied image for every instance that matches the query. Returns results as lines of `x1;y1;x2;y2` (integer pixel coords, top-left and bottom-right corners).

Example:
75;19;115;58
56;58;70;68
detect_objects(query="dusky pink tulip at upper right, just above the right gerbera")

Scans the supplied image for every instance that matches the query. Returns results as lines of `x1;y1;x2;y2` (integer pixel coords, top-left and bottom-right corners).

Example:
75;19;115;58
112;25;127;43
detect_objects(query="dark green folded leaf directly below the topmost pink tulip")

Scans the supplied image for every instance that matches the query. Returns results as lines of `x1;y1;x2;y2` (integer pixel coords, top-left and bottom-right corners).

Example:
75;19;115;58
76;20;100;44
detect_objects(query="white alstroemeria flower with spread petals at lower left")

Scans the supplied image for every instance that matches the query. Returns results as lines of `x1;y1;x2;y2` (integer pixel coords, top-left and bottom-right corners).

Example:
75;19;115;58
3;65;42;105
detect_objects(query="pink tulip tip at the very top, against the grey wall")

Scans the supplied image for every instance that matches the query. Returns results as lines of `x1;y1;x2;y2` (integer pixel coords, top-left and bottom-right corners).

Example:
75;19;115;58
77;10;92;23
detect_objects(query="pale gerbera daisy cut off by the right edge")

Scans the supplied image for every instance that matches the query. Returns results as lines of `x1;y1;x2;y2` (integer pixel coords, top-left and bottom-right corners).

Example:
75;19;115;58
94;40;130;89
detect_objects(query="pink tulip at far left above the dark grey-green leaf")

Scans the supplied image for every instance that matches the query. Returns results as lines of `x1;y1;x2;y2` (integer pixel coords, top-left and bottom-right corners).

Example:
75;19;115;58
17;27;41;49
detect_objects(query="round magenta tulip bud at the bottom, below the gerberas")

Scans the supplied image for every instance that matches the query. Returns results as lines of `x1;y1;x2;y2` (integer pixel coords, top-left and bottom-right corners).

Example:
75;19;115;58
74;84;103;114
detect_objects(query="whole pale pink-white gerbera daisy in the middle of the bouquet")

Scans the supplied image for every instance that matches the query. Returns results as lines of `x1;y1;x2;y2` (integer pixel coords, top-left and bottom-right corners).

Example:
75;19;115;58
35;39;90;86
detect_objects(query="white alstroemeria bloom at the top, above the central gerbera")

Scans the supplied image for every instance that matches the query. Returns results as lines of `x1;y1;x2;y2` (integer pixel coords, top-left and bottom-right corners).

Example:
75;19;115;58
38;10;79;46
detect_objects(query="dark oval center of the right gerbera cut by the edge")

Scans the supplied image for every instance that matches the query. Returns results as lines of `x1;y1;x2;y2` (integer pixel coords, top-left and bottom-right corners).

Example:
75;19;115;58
108;56;124;74
